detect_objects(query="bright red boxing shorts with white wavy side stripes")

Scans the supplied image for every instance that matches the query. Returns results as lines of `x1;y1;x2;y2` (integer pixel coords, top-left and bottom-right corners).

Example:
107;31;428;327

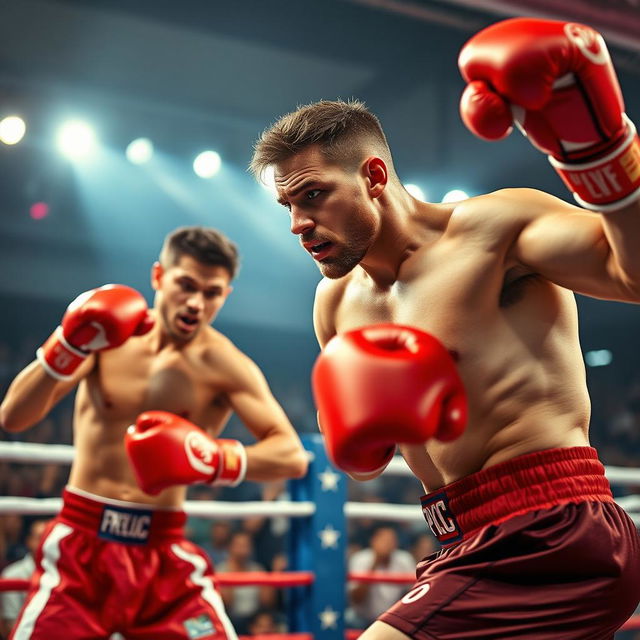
11;488;237;640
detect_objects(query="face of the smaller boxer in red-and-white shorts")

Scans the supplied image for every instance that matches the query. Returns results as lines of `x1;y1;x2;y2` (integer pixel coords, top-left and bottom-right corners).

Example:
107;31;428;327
152;255;232;341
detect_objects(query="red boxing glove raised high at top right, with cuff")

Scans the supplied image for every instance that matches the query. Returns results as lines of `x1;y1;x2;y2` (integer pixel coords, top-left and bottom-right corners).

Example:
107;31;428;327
458;18;640;211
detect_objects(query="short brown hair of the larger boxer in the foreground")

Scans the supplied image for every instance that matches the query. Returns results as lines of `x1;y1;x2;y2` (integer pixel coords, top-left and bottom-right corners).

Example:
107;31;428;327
249;100;392;179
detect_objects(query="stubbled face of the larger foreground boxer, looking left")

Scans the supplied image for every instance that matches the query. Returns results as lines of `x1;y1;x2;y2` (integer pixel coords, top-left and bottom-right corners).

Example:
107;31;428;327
274;146;379;278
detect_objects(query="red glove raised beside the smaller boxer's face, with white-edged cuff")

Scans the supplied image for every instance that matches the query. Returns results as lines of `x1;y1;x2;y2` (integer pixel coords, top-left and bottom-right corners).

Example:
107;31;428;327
36;284;153;380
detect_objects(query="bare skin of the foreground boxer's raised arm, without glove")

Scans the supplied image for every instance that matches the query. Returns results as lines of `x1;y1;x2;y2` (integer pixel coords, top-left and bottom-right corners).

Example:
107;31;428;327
487;189;640;302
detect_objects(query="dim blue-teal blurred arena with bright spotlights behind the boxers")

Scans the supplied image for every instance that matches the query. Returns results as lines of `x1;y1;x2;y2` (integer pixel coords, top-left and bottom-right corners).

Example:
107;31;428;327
0;0;640;636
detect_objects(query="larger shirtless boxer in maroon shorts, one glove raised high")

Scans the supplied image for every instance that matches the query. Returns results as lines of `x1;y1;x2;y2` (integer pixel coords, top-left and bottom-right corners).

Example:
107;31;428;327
252;19;640;640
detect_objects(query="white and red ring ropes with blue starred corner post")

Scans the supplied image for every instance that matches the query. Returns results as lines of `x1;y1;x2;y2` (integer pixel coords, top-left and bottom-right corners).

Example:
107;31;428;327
0;434;640;640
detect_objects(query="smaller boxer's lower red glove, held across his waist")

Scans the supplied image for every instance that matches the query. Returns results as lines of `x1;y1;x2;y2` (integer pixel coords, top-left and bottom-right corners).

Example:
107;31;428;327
124;411;247;495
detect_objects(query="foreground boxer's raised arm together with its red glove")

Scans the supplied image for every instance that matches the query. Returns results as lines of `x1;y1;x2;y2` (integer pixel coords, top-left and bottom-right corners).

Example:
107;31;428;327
458;18;640;302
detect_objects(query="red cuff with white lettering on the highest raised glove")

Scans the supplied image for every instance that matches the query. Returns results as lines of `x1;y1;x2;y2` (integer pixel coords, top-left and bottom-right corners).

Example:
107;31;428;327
549;116;640;212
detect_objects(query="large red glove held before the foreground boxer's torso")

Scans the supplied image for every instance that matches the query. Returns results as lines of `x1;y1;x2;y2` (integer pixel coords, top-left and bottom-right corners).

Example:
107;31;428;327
312;324;467;473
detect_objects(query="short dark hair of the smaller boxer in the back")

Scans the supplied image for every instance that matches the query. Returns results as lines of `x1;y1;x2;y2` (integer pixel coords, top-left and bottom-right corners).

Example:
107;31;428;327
160;227;240;280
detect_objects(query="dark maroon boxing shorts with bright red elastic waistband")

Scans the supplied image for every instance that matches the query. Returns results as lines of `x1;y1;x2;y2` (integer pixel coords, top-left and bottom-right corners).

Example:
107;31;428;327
379;447;640;640
